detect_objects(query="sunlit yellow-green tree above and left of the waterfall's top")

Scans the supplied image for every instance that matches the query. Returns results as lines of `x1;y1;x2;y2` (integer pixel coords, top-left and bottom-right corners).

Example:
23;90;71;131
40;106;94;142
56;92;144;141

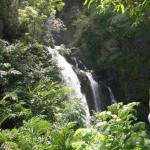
18;0;64;45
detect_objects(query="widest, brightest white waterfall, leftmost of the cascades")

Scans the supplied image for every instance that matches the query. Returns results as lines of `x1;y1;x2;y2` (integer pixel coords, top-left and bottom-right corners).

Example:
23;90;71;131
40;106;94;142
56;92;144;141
48;46;90;125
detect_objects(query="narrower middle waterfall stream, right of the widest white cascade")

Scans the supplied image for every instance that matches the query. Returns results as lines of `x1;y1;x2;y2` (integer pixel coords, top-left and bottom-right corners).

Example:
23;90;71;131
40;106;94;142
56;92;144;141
85;72;100;112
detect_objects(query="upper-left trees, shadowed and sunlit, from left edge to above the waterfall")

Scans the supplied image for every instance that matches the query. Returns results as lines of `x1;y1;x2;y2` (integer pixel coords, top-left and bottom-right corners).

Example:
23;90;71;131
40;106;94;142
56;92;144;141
0;0;64;43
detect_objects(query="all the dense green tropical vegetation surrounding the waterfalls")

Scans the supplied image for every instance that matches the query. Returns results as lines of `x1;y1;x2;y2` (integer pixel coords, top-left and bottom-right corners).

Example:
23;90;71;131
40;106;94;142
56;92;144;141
0;0;150;150
